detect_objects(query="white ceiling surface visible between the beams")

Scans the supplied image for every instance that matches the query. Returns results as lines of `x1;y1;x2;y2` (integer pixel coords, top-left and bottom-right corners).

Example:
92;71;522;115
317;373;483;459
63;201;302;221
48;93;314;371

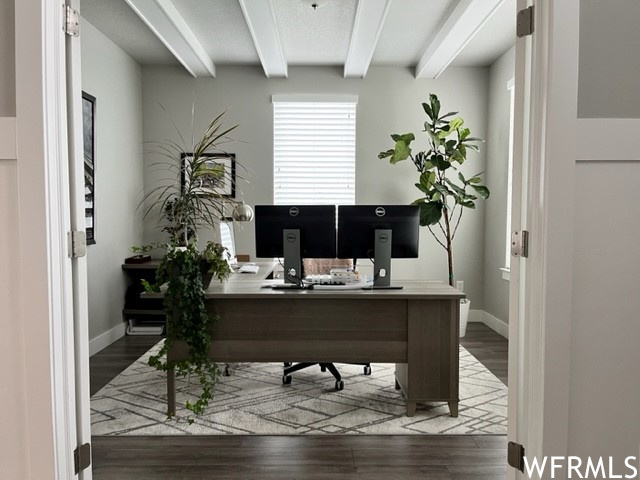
81;0;516;74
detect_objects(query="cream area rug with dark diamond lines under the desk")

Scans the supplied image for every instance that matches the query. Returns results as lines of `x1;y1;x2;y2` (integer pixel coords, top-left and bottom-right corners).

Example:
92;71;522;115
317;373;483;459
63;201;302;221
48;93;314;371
91;344;507;435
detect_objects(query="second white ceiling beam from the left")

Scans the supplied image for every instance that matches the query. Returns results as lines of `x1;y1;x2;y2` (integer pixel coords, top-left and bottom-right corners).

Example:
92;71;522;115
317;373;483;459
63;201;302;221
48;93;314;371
240;0;288;78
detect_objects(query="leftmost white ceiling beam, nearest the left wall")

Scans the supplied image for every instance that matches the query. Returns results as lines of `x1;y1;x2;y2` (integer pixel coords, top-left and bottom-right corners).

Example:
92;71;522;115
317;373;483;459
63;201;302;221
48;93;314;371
126;0;216;77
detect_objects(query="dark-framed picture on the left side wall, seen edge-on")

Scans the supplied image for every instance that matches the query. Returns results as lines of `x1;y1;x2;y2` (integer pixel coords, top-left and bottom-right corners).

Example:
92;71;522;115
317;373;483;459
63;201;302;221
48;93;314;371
82;92;96;245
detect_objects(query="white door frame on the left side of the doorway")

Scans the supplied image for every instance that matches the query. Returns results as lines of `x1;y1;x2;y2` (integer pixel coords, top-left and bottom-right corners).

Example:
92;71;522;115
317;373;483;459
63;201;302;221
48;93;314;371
15;0;84;480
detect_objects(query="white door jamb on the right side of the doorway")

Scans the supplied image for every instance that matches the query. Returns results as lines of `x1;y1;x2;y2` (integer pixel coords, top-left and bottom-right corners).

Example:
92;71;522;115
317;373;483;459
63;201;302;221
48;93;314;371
509;0;580;478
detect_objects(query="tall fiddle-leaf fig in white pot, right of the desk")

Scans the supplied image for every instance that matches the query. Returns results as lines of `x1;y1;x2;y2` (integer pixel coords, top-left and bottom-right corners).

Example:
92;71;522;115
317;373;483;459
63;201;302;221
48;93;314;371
378;94;490;336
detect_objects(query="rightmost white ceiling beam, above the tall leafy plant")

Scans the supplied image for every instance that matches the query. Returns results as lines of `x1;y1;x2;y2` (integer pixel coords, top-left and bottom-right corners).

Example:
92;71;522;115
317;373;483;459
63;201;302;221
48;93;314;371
415;0;504;78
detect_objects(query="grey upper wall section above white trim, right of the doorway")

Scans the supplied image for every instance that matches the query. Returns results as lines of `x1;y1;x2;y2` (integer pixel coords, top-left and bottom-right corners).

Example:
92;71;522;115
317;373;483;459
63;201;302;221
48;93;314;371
578;0;640;118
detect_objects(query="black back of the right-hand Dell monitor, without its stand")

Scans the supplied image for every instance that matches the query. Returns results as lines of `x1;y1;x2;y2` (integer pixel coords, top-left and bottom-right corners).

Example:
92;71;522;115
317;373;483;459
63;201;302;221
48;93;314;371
338;205;420;258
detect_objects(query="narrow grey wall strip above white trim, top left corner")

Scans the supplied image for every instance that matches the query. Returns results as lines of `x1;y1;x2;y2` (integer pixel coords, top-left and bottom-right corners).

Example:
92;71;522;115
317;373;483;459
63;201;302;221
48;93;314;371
0;0;16;117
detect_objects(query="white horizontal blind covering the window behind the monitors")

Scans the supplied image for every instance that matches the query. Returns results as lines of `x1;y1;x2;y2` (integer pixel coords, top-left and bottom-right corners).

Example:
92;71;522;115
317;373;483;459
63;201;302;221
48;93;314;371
273;96;356;205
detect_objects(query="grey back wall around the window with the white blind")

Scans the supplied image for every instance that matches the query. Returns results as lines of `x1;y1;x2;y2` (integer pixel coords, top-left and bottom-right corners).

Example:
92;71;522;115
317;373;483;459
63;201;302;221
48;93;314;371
142;67;488;308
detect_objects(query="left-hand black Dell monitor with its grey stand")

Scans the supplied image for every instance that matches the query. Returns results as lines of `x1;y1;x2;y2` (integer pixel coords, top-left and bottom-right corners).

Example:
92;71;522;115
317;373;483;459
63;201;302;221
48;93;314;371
255;205;336;284
